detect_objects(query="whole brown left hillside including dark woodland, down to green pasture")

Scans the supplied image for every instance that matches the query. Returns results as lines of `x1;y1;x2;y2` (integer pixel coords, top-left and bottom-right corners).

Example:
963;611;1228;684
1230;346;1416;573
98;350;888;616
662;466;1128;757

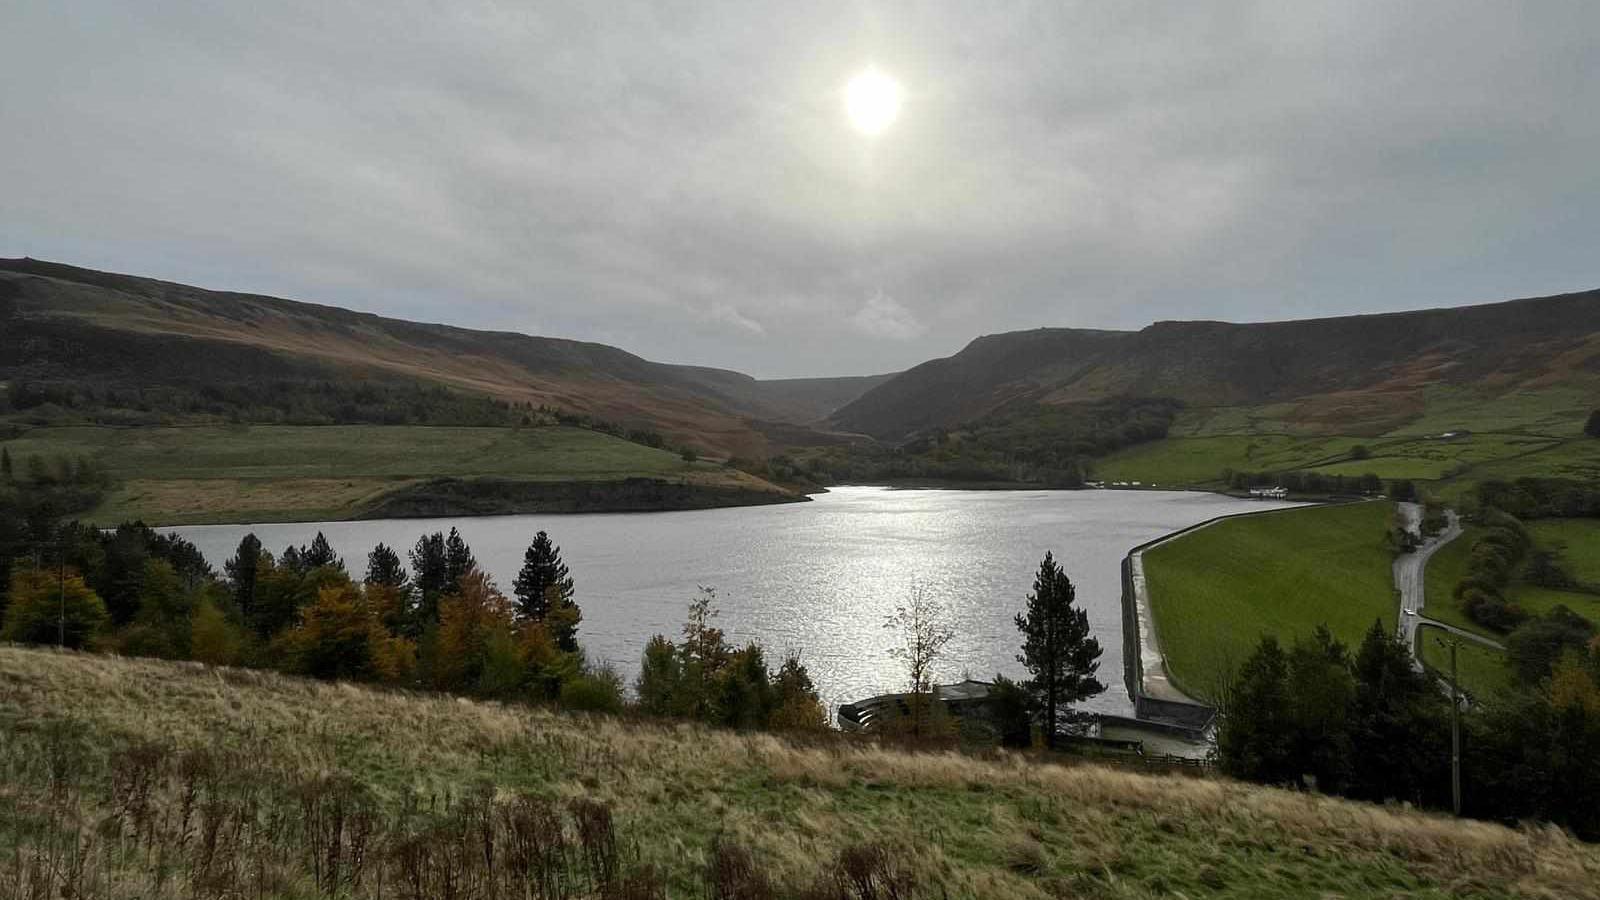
0;259;877;458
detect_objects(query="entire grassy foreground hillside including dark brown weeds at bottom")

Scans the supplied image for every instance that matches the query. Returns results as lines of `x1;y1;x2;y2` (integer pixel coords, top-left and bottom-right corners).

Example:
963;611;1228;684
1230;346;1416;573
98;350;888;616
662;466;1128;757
0;647;1600;897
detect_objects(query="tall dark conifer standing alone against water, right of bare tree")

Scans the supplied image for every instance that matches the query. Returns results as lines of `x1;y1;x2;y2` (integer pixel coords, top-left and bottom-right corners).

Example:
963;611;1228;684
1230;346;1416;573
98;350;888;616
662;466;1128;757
1016;552;1106;748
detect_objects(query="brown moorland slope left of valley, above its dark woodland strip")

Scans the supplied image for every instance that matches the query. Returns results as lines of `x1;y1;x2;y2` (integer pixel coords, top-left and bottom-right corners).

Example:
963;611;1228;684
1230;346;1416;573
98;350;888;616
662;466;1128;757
0;259;877;456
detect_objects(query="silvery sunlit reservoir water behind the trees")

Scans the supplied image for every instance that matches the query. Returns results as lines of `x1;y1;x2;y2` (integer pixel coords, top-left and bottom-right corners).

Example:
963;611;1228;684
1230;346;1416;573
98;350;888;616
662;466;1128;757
174;487;1290;713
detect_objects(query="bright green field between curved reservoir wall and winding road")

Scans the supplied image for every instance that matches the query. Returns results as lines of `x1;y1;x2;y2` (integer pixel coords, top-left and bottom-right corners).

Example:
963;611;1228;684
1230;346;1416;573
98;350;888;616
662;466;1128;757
1144;501;1398;697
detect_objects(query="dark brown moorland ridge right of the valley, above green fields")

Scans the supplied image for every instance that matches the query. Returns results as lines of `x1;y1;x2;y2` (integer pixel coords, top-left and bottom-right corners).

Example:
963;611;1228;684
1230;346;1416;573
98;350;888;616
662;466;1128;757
830;291;1600;439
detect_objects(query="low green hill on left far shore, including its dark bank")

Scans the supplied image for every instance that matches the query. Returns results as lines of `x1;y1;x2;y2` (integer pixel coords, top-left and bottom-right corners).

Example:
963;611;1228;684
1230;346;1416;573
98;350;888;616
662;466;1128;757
5;424;802;525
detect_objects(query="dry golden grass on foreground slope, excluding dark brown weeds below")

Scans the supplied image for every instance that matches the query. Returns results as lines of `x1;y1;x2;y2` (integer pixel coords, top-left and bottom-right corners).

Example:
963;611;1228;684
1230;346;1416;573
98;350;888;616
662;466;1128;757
0;647;1600;898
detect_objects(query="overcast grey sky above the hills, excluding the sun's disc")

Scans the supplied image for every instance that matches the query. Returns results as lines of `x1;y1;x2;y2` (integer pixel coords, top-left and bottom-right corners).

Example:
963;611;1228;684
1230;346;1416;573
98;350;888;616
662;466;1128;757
0;0;1600;376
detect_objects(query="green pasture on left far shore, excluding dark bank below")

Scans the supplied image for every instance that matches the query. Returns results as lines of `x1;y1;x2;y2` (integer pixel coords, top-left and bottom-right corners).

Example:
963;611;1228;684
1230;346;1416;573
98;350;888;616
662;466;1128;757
5;424;793;525
